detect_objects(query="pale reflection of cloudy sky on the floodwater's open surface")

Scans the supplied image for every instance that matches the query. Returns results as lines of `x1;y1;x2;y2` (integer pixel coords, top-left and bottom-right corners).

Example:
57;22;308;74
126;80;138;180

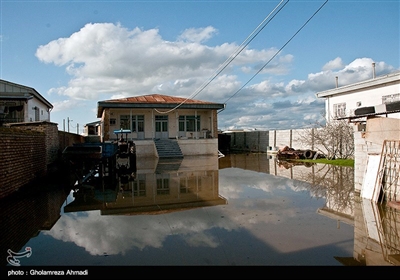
40;168;353;262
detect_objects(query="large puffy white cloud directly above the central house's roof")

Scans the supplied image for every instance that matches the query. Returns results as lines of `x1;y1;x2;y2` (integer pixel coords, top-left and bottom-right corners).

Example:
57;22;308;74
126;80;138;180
36;23;291;100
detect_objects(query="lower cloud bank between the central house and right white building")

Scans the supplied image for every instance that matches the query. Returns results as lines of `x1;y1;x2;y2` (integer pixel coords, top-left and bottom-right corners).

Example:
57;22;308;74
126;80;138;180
218;58;395;130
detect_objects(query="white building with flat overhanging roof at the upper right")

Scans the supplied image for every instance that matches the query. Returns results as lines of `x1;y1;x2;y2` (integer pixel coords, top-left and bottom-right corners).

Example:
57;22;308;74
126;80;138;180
317;69;400;121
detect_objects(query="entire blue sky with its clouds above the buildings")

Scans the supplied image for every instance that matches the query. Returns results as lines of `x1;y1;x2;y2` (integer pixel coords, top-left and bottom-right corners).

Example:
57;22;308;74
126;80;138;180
0;0;400;133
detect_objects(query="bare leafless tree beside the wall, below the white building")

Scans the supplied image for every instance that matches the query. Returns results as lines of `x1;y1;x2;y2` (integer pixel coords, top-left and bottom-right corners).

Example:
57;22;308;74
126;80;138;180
299;120;354;159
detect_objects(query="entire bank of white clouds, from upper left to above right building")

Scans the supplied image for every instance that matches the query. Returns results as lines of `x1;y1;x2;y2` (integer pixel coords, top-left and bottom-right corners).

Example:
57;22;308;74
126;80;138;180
36;23;395;129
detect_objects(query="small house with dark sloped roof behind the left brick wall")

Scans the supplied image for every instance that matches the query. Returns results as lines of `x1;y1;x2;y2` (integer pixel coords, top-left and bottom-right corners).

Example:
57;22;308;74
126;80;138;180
0;80;53;125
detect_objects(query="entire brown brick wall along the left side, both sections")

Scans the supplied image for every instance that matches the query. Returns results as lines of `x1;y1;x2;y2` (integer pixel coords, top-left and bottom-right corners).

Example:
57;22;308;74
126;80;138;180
0;122;85;198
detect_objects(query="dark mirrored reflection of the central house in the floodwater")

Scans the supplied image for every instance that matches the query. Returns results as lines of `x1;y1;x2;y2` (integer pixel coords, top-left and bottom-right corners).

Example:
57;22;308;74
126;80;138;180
64;156;227;215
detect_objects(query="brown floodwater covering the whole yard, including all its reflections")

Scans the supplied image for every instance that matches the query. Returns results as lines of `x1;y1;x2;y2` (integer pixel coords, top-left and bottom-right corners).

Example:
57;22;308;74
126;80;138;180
0;154;400;274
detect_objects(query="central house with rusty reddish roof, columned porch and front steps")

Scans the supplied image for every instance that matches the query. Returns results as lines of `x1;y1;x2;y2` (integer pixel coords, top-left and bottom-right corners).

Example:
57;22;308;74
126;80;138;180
97;94;225;156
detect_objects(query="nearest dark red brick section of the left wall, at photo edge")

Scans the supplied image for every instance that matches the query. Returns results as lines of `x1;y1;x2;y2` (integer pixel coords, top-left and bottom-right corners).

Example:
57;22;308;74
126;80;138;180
0;127;47;198
